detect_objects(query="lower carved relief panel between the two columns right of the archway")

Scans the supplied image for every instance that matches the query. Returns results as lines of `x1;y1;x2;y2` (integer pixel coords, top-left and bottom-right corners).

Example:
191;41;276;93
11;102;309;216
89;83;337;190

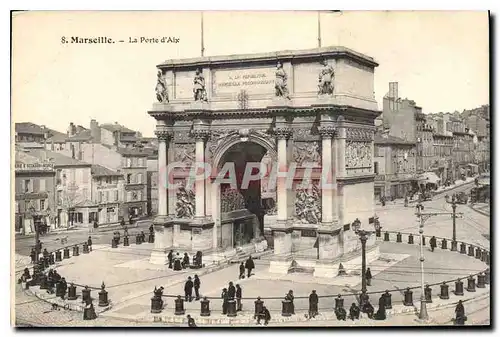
295;184;321;224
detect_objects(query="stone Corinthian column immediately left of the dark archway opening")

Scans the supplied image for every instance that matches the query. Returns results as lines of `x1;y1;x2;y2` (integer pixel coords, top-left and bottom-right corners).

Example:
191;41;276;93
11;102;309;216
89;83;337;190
191;129;210;219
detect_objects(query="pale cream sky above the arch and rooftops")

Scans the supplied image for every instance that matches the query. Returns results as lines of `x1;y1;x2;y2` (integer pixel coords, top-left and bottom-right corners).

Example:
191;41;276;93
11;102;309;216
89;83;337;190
12;11;489;136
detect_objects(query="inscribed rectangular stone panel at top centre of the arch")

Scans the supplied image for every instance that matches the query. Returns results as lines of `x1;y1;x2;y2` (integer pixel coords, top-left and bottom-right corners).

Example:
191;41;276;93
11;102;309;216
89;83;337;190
212;67;275;96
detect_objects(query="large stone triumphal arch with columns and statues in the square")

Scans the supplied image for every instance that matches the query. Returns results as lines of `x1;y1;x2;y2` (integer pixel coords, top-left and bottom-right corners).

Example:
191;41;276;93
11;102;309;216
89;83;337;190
148;47;380;277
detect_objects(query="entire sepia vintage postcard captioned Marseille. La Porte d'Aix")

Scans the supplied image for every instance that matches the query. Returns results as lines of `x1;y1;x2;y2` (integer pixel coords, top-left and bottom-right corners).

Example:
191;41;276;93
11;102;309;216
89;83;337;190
11;11;491;329
